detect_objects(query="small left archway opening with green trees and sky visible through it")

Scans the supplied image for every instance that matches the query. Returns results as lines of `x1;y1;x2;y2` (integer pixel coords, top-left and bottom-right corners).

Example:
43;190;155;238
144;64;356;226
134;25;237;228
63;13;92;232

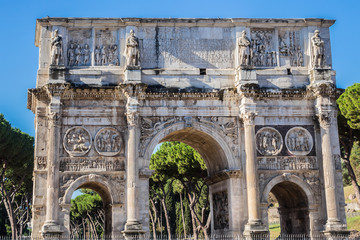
69;182;112;239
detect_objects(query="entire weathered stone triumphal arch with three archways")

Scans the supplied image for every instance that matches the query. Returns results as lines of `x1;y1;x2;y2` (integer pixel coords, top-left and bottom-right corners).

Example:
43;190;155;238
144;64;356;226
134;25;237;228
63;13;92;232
28;18;346;238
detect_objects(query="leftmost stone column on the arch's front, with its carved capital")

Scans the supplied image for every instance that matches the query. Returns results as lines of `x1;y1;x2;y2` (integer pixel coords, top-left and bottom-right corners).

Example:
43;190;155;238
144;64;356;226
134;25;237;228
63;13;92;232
42;84;66;238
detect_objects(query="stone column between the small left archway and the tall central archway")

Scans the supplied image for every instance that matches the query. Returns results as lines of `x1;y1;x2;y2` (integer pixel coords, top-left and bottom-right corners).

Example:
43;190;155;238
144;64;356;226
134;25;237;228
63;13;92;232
121;84;146;239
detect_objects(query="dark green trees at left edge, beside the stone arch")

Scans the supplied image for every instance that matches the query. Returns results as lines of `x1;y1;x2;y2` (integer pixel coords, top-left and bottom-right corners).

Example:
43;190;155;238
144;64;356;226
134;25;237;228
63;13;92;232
0;114;34;239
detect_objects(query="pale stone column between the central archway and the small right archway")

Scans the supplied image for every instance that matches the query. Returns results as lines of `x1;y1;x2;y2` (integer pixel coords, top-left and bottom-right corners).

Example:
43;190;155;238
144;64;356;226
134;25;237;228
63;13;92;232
240;111;266;236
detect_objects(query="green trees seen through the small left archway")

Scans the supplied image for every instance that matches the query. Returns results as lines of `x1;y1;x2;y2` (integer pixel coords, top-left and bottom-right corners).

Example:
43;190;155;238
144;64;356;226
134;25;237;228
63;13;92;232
70;189;105;239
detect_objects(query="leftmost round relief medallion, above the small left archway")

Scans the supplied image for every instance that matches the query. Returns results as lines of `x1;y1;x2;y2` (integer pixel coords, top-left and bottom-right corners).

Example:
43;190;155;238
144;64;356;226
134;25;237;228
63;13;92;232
63;127;92;157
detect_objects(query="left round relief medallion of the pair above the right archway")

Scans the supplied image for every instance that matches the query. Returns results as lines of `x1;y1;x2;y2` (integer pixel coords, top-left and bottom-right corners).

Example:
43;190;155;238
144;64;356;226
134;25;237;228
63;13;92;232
255;127;283;156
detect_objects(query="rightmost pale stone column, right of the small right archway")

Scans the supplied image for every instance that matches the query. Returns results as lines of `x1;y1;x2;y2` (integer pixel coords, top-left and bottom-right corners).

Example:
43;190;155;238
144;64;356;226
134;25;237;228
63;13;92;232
318;108;342;231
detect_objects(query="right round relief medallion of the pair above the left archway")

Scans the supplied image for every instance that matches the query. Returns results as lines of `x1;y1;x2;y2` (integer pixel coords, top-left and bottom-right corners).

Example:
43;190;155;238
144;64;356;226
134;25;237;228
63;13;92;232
95;127;122;156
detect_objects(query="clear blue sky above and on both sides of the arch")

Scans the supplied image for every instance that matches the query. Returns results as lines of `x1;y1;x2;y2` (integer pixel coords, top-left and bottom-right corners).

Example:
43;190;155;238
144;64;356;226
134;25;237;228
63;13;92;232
0;0;360;135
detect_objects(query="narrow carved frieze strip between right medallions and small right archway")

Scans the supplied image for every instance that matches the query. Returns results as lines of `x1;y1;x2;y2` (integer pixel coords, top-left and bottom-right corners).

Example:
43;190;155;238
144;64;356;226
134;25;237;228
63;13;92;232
257;156;318;170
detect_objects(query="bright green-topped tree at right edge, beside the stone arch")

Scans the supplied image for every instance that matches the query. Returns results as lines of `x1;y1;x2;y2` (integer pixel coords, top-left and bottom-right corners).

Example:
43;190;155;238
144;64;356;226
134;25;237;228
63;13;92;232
336;83;360;204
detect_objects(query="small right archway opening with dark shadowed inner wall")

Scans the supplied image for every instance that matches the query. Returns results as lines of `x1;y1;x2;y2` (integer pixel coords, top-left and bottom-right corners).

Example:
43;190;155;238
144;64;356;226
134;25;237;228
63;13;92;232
268;181;310;235
